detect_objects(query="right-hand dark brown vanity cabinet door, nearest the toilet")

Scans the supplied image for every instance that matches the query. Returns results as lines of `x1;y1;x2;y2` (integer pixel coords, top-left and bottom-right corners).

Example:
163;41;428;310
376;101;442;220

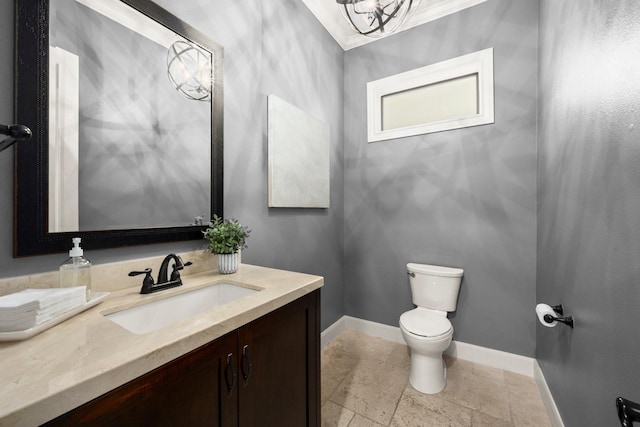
238;290;320;427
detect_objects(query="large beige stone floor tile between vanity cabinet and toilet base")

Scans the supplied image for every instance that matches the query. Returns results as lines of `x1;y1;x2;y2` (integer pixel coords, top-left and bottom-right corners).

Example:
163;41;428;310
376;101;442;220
331;360;408;425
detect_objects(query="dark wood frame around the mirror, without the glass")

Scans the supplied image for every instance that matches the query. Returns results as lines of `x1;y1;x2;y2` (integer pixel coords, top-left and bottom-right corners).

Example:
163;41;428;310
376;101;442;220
13;0;224;257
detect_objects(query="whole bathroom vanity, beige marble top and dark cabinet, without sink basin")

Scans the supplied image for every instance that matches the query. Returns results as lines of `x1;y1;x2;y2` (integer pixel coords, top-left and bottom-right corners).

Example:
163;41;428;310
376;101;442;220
0;265;323;426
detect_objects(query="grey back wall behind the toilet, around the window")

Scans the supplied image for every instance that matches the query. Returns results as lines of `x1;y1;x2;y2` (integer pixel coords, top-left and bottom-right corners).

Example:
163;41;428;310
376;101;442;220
344;0;538;356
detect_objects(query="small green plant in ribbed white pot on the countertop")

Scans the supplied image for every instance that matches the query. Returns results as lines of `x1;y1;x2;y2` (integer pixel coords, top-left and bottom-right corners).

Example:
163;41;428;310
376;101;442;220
202;215;251;274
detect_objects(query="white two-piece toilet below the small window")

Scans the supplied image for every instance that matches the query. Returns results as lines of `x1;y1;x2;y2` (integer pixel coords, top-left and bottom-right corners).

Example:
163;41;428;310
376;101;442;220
400;263;464;394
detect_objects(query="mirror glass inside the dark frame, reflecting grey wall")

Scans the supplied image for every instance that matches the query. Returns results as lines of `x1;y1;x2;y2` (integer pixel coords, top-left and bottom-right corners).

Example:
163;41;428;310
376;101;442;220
49;0;212;232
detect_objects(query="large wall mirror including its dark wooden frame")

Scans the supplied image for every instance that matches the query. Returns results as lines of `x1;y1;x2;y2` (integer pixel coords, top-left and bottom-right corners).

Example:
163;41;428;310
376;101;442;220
14;0;224;257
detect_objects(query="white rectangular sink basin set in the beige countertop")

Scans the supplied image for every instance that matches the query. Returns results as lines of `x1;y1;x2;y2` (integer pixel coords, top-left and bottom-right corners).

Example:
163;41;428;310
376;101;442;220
105;283;258;334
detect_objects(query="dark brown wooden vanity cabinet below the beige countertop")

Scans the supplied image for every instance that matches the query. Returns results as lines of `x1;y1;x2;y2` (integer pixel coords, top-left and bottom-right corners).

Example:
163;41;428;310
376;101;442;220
45;290;320;427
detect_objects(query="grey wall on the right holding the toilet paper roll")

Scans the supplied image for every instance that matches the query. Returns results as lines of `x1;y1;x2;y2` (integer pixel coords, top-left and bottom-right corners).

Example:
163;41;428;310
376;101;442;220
536;0;640;427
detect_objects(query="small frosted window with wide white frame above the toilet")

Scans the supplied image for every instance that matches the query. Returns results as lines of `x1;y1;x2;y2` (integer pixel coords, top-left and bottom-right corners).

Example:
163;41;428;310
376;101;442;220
367;48;494;142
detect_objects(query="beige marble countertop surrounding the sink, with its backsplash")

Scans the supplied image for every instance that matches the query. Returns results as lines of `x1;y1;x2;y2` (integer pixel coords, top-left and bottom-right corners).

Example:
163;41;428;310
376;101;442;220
0;264;323;426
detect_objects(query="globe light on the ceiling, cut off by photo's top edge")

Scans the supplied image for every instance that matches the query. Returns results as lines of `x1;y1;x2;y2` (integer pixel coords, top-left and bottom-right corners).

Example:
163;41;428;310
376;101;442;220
336;0;420;37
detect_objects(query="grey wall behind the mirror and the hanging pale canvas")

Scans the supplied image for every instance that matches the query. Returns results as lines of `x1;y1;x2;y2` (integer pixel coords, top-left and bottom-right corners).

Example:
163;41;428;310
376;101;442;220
0;0;344;327
